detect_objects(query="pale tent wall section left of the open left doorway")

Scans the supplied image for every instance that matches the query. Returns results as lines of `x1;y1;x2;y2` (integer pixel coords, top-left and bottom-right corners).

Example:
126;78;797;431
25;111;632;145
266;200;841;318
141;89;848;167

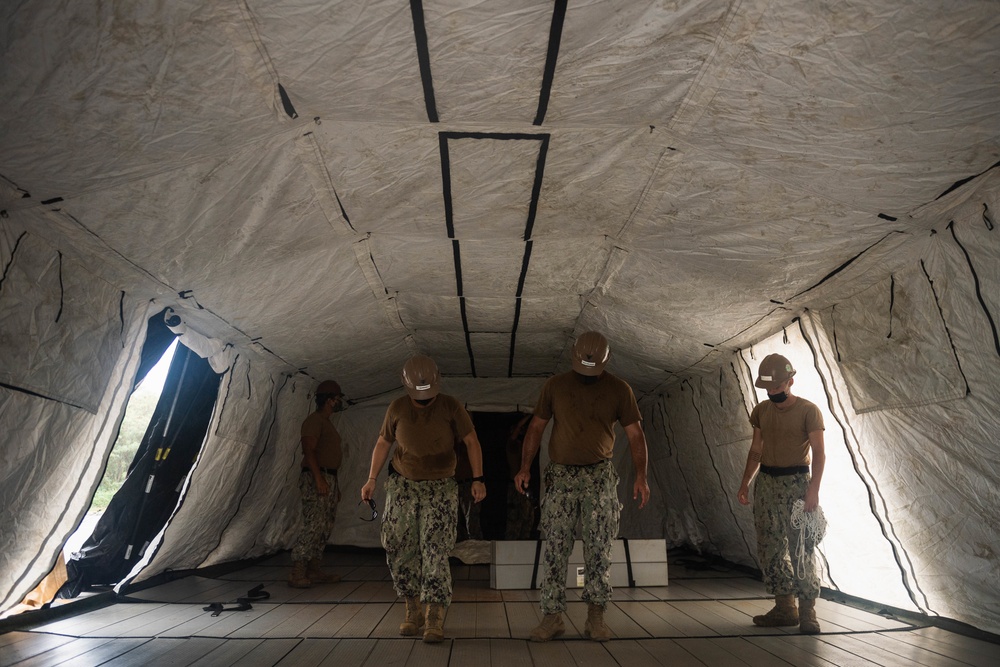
0;218;156;609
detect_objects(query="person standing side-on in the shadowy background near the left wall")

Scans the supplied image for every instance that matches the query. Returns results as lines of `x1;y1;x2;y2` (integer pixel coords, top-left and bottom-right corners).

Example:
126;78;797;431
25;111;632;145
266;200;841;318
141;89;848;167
288;380;344;588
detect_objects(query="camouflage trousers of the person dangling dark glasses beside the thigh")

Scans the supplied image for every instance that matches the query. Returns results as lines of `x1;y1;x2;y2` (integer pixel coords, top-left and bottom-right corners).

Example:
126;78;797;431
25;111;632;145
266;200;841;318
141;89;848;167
382;475;458;606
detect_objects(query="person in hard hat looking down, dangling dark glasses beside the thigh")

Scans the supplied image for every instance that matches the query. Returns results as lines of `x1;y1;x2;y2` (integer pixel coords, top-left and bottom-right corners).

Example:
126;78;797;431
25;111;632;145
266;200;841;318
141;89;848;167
361;356;486;642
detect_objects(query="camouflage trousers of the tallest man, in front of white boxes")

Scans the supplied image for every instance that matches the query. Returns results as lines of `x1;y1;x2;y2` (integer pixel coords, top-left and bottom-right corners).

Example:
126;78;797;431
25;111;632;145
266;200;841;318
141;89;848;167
541;461;622;614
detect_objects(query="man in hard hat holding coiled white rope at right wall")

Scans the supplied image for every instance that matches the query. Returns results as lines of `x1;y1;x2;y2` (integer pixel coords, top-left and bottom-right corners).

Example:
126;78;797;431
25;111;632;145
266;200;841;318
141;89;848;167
736;354;826;634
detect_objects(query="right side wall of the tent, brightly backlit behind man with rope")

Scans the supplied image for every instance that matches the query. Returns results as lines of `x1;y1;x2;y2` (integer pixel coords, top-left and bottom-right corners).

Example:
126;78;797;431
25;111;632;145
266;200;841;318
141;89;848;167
644;176;1000;632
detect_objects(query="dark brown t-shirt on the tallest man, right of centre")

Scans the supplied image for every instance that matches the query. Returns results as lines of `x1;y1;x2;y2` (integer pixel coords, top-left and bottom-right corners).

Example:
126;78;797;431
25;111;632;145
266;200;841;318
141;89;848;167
535;371;642;465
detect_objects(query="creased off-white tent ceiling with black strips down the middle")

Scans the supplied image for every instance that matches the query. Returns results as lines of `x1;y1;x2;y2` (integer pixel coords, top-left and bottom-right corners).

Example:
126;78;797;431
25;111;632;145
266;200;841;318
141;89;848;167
0;0;1000;397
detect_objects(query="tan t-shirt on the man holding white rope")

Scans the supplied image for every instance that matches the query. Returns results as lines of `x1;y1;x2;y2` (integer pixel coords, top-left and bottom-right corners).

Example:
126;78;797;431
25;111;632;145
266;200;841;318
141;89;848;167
750;396;823;468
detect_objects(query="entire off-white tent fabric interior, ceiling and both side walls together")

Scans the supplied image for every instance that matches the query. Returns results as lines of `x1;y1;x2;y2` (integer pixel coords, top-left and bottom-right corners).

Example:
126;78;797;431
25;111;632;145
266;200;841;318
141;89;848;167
0;0;1000;633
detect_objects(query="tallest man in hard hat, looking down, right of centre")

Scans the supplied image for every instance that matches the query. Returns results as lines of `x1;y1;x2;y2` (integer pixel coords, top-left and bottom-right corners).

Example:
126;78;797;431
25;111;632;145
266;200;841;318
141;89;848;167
514;331;649;641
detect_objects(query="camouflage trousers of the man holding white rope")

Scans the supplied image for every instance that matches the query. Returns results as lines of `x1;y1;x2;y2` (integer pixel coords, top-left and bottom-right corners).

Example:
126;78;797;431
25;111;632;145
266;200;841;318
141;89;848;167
753;473;819;599
